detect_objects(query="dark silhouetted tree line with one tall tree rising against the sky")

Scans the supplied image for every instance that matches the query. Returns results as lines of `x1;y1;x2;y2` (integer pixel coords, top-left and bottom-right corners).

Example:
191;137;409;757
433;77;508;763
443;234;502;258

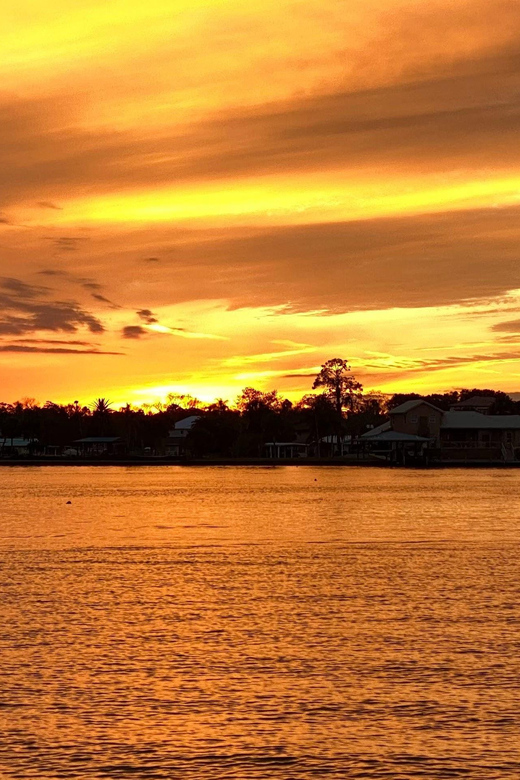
0;358;520;457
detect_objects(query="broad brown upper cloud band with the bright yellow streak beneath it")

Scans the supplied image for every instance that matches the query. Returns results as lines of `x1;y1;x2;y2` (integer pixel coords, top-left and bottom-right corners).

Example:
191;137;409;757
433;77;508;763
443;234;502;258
0;50;520;225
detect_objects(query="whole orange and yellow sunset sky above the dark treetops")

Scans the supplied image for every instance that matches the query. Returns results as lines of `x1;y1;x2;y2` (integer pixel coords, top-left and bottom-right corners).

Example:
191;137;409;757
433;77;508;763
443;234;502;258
0;0;520;404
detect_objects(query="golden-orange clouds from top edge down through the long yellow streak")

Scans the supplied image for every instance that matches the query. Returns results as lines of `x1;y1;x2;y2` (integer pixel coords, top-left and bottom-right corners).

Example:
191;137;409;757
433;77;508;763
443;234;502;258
0;0;520;224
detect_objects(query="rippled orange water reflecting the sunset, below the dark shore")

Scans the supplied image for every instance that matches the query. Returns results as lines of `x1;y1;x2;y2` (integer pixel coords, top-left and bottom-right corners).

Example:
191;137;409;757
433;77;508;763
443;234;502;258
0;467;520;780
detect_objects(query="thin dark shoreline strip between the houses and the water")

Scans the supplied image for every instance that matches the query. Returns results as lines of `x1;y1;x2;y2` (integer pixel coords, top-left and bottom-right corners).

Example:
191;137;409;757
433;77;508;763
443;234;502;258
0;458;520;470
